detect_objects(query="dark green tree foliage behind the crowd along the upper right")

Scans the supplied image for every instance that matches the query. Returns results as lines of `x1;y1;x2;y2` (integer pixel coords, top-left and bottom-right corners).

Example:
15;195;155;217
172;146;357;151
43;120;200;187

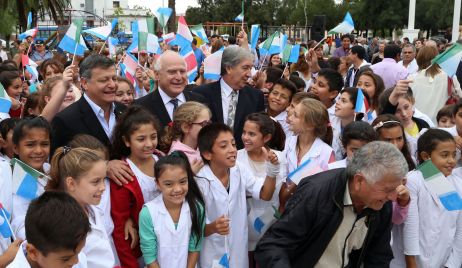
186;0;462;36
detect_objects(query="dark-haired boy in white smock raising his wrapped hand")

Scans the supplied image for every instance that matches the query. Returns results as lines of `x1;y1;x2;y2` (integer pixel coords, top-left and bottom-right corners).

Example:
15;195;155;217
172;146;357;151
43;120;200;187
197;124;279;268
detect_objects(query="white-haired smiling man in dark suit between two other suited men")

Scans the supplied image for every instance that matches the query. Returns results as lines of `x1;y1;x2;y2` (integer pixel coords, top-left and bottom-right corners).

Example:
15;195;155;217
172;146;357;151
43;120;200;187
135;51;206;128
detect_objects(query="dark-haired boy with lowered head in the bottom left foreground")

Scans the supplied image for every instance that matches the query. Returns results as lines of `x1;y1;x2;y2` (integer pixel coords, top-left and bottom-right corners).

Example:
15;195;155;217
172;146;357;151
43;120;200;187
7;192;90;268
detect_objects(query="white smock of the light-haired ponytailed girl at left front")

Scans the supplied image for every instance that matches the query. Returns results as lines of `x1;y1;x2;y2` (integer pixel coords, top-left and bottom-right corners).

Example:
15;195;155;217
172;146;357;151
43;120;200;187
74;206;115;268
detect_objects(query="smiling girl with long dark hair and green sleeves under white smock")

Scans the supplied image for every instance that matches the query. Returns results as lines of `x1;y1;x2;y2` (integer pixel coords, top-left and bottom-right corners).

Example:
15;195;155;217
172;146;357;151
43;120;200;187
139;151;205;268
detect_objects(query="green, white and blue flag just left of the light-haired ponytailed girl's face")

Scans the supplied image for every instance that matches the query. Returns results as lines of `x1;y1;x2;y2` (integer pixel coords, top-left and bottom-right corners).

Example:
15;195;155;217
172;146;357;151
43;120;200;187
11;158;47;200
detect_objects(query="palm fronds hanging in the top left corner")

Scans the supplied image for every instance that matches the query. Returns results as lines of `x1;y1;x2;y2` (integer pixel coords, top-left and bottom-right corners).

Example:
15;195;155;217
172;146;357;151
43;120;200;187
0;0;71;31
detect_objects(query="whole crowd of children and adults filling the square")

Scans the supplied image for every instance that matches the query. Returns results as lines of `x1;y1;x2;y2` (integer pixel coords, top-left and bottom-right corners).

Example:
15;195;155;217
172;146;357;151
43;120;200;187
0;27;462;268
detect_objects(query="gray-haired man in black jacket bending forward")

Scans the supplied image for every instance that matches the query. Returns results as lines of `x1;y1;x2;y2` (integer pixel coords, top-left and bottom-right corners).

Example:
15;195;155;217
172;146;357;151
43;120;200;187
255;142;408;268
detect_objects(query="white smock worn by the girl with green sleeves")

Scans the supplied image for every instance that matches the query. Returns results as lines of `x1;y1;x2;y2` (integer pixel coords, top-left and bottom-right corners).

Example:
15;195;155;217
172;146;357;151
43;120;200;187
144;195;192;268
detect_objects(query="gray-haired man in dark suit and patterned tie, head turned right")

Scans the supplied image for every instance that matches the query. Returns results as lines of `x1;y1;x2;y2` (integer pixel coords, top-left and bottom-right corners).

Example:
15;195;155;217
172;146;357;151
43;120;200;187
194;47;265;149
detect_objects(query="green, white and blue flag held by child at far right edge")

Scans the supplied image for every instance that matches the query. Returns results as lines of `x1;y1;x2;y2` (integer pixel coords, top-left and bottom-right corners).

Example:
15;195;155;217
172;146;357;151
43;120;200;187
417;160;462;211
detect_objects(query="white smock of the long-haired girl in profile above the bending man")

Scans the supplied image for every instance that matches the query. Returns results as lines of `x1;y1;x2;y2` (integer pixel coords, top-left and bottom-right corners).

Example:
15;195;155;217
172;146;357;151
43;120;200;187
284;136;334;174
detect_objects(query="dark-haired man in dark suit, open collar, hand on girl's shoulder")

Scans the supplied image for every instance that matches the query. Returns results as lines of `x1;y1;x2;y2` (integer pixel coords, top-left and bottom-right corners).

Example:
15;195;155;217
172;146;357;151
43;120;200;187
51;54;133;185
